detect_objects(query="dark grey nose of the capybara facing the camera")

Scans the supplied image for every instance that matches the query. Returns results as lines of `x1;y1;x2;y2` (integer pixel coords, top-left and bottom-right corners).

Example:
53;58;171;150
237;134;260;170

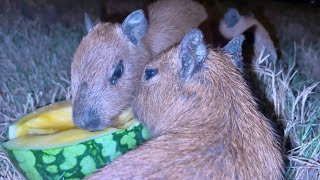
72;108;104;131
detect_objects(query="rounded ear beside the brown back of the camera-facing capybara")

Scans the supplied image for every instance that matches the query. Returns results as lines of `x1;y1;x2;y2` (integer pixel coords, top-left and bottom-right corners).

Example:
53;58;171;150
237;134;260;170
121;9;148;45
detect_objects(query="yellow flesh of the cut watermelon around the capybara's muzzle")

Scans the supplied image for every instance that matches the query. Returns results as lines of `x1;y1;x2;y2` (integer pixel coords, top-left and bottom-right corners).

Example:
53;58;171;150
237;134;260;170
9;101;133;139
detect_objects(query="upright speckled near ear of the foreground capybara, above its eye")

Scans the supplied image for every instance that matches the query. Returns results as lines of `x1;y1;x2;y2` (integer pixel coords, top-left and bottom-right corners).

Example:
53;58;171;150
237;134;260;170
179;29;207;80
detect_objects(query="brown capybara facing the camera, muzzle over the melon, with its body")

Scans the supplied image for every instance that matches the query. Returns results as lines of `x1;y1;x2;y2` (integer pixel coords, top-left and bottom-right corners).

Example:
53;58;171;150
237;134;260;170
71;0;207;131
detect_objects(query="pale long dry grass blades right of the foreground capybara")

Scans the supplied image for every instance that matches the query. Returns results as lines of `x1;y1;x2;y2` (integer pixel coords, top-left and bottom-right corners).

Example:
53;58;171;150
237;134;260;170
254;46;320;179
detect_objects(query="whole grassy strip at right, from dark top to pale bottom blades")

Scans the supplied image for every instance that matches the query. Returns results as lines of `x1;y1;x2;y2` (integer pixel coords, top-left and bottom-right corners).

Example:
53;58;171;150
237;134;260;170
257;4;320;179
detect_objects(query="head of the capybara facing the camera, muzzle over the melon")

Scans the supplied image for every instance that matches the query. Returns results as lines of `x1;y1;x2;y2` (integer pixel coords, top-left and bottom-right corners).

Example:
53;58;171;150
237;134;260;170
71;10;149;131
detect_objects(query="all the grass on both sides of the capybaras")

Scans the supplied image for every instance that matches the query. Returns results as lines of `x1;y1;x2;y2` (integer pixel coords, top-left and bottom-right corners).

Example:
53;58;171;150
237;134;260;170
0;1;320;179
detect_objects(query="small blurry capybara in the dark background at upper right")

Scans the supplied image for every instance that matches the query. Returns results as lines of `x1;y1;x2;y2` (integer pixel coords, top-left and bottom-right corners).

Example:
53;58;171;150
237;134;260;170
219;8;278;62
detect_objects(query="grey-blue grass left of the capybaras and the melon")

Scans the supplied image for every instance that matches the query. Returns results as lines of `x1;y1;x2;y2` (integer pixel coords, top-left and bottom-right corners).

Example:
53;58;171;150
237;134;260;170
0;6;84;179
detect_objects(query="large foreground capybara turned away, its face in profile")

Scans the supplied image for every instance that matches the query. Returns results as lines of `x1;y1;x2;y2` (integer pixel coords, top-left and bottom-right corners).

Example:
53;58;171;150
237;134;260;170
89;30;283;180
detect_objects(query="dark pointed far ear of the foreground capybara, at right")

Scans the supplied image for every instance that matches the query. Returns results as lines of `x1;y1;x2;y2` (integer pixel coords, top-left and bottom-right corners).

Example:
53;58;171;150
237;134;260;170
223;35;244;72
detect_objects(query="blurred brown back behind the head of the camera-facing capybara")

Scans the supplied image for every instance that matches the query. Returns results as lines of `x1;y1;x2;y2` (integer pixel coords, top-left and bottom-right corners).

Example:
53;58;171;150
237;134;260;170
146;0;208;55
